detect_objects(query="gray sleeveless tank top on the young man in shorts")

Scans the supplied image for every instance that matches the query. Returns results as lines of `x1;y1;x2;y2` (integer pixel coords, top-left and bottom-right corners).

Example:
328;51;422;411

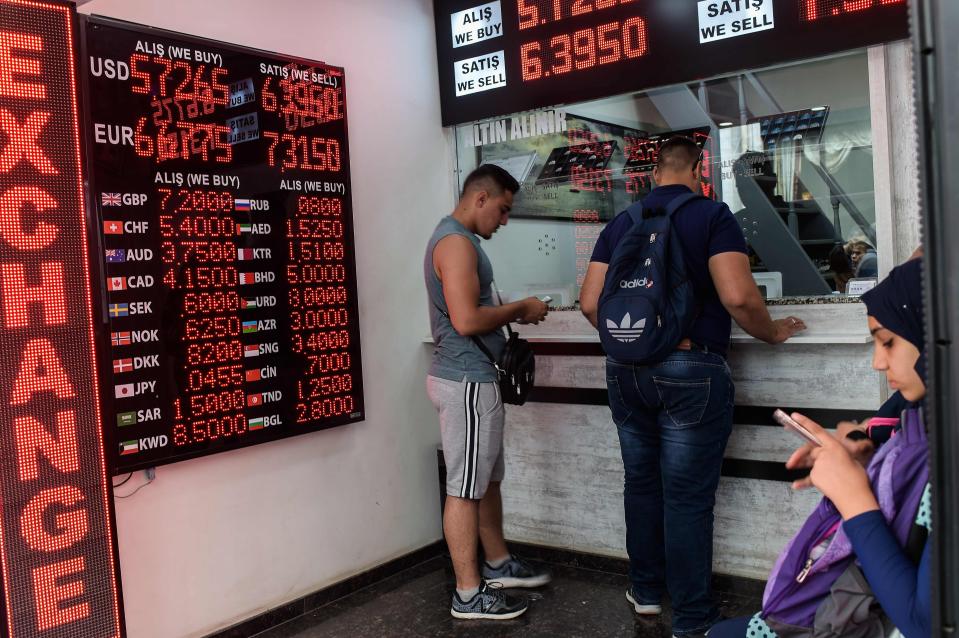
423;216;506;382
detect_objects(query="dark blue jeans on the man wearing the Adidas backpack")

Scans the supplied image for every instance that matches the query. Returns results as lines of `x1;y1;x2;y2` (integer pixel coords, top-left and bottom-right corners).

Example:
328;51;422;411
606;351;734;635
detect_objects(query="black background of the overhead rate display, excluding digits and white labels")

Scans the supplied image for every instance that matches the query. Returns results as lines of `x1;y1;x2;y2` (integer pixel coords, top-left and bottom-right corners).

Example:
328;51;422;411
433;0;909;126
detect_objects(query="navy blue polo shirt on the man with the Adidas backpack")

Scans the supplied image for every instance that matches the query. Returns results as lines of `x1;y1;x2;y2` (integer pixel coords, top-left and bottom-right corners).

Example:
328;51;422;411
590;184;748;356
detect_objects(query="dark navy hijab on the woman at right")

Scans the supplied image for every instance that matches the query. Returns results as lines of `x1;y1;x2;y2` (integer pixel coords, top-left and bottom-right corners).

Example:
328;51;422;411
862;259;926;382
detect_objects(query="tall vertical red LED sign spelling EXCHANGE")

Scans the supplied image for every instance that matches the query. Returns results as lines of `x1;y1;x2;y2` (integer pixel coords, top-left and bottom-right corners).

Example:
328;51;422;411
0;0;124;638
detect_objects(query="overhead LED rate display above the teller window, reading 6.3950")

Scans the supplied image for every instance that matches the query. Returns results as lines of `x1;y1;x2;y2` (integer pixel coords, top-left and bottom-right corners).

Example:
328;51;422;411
434;0;909;125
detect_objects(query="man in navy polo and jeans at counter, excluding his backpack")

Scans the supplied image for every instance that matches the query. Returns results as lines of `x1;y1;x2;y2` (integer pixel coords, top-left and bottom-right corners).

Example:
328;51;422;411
580;137;805;637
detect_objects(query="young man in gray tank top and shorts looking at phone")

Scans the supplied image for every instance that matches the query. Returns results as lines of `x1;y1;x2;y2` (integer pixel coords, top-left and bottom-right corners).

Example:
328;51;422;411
423;164;549;619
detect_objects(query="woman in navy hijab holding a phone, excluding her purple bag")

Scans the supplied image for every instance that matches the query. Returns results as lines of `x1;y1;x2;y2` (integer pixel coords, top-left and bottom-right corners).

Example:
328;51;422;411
709;260;932;638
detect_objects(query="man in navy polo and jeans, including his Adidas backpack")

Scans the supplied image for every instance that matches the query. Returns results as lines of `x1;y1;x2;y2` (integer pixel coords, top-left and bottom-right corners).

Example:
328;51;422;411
580;137;805;637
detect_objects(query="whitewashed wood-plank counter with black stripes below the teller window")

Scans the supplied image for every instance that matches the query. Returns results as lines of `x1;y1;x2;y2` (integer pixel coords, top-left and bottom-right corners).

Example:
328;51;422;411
472;298;885;579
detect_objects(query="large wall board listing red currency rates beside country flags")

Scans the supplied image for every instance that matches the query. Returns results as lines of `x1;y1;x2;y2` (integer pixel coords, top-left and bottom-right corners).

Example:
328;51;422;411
80;18;363;473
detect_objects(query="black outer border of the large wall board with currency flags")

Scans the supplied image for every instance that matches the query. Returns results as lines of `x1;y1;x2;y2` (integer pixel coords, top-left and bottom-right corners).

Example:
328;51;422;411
77;14;366;476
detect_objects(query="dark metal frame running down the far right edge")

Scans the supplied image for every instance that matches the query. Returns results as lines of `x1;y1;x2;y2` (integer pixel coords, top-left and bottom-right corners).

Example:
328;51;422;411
910;0;959;636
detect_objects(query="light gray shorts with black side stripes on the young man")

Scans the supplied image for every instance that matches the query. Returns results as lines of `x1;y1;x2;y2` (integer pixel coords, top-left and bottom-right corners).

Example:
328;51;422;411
426;376;506;499
